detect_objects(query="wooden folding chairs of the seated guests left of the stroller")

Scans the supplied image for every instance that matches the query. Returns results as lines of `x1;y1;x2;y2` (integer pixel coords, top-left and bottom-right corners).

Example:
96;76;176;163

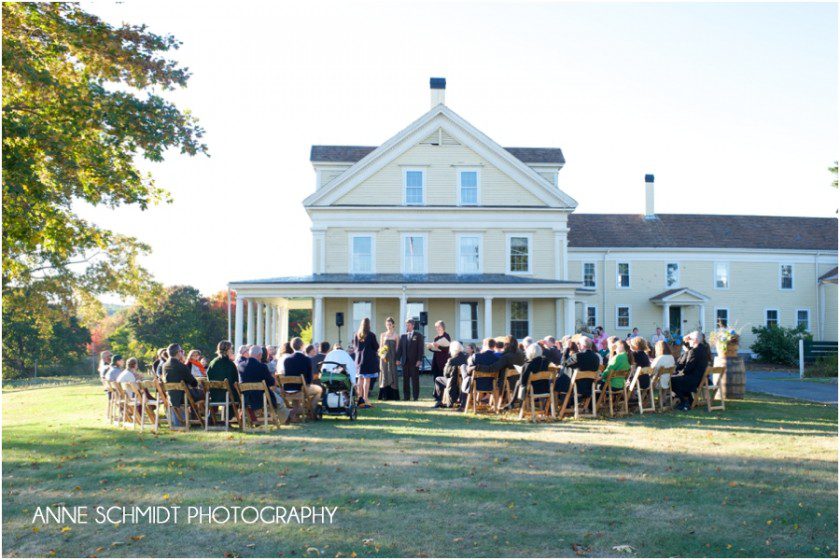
102;374;318;433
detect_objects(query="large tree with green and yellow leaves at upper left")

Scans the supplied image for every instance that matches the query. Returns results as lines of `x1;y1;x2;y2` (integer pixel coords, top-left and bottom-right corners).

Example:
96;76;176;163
2;2;206;372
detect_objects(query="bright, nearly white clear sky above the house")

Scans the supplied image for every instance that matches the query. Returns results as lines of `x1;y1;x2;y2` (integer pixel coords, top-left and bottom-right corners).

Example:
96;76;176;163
78;0;838;302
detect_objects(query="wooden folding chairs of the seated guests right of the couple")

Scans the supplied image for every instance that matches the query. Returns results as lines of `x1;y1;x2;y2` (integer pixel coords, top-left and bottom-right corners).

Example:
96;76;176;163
466;366;726;422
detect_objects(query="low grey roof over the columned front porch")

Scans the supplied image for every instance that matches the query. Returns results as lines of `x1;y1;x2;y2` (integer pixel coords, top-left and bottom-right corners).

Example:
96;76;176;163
231;273;580;286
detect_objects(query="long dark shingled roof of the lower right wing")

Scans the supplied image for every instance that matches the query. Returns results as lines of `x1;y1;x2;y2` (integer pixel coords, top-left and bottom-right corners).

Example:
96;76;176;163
568;213;837;251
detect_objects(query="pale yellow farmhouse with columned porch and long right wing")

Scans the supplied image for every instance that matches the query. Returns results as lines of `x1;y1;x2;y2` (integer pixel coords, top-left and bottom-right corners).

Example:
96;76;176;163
230;78;837;348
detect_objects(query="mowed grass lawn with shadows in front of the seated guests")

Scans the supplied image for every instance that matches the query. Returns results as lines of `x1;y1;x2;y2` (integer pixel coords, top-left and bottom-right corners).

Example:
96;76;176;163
3;379;837;557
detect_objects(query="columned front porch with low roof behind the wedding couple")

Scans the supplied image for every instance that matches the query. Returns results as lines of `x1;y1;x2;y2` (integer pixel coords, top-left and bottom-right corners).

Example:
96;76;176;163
229;274;580;346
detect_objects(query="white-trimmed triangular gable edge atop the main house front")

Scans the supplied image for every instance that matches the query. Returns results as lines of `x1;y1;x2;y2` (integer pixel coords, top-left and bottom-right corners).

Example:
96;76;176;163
303;104;577;209
